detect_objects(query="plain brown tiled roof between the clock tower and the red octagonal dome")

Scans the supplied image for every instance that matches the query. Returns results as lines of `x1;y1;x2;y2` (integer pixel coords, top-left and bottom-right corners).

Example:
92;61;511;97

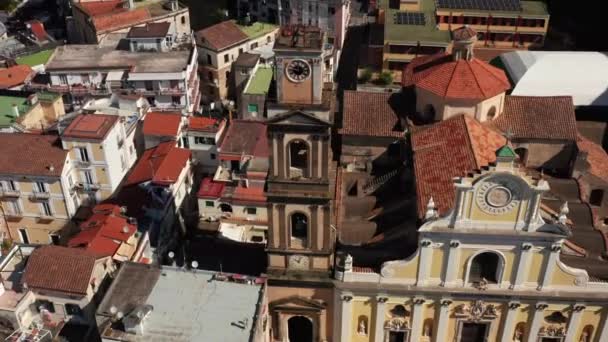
339;90;403;138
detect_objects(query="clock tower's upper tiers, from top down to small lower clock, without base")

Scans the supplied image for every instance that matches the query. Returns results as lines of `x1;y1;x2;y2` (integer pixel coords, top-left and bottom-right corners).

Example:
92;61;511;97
266;26;335;274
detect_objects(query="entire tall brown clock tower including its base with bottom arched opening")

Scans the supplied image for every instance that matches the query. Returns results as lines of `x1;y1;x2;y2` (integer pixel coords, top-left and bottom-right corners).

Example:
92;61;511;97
266;26;336;342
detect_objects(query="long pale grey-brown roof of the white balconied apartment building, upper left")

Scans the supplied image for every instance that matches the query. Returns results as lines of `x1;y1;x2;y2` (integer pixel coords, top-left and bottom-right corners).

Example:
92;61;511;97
46;45;191;73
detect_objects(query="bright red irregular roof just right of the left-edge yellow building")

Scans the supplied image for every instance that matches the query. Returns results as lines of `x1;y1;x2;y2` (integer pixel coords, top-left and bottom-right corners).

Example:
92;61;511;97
68;204;137;257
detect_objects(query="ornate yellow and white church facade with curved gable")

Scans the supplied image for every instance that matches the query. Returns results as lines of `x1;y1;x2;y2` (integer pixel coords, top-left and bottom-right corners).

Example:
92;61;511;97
334;146;608;342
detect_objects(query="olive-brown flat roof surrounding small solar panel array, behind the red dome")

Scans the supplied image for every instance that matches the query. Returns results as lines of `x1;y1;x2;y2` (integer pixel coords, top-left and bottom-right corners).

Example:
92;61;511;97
381;0;451;46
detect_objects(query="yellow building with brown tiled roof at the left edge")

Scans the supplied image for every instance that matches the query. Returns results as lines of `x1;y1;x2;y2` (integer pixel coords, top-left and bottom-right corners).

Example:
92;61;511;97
0;133;76;244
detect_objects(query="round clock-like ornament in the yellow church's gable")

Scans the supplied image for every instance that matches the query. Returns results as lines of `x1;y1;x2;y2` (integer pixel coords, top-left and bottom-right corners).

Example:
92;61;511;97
476;177;522;215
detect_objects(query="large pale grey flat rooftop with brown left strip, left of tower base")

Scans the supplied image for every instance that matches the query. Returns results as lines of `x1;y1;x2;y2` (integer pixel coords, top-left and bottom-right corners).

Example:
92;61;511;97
98;263;264;341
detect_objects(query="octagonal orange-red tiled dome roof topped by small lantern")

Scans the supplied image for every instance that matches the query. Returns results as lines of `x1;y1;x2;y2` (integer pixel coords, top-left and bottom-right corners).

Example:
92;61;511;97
402;53;511;100
